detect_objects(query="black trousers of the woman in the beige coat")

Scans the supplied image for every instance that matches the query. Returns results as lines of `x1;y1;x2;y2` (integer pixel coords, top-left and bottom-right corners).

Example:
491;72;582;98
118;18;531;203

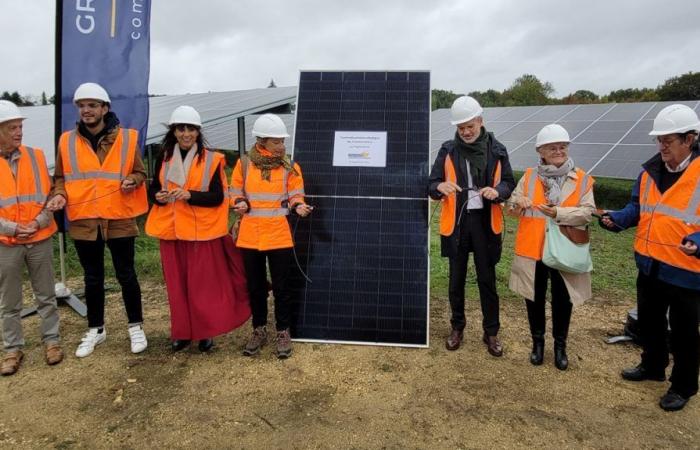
525;261;572;343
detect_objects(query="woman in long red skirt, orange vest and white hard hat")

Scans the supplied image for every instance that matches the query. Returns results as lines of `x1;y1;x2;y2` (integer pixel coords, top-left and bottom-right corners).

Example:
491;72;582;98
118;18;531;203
146;106;250;352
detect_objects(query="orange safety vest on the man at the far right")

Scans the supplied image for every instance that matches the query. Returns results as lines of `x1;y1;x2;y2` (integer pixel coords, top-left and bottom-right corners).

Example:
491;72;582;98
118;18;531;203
634;158;700;273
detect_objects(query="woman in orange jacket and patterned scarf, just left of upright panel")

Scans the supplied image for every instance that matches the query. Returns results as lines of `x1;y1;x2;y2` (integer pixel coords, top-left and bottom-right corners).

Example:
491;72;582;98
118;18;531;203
230;114;312;359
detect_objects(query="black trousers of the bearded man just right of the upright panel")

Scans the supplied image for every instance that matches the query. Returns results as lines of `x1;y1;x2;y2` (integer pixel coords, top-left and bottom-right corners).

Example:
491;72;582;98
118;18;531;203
449;210;501;336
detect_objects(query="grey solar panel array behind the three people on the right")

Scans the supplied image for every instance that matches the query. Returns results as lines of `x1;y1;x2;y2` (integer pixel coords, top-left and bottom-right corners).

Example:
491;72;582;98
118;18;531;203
431;101;700;179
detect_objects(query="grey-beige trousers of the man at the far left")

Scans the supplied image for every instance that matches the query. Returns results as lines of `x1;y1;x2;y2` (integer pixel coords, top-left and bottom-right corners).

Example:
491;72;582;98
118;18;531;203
0;239;59;351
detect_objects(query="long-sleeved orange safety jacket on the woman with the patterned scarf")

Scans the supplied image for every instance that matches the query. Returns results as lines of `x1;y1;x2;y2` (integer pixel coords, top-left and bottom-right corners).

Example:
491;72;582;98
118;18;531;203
229;159;304;251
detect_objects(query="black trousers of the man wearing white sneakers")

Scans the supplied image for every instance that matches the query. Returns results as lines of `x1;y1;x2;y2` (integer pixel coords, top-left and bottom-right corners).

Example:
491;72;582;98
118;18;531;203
74;236;143;328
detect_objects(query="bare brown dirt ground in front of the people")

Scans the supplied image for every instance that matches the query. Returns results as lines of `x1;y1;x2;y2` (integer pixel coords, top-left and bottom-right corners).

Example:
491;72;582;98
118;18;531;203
0;284;700;449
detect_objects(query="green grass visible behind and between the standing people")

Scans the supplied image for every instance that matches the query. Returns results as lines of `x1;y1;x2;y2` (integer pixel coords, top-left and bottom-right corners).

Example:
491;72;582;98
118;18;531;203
55;179;636;298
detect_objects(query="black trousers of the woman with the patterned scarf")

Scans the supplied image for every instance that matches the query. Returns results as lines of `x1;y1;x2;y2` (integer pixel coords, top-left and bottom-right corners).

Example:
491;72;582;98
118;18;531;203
241;248;294;331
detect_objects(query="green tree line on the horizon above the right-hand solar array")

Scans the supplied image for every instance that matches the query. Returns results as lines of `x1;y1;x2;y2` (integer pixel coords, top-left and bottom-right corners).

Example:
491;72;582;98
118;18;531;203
432;72;700;110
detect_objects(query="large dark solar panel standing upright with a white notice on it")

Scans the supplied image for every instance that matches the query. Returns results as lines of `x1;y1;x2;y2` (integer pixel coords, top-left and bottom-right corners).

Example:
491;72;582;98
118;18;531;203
292;72;430;346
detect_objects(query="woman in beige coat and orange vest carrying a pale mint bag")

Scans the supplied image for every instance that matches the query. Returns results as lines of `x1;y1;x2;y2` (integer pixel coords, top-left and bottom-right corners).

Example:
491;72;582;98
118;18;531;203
509;124;595;370
